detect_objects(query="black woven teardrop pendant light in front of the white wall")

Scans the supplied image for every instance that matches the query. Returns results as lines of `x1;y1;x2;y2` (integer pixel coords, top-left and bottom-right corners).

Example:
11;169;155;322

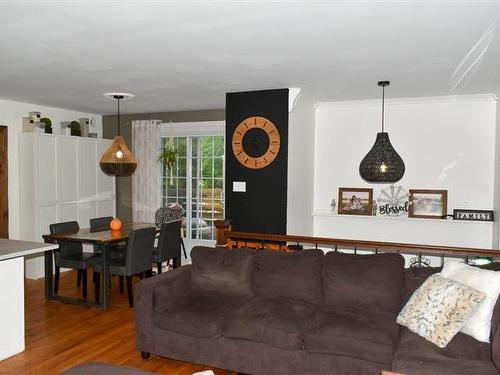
359;81;405;183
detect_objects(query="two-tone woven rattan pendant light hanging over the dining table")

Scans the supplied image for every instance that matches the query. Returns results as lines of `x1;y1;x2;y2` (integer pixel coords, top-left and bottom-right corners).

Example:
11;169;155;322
99;93;137;176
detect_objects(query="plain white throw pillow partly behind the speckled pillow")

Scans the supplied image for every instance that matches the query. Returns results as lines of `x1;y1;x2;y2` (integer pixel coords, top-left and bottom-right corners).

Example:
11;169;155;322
441;261;500;342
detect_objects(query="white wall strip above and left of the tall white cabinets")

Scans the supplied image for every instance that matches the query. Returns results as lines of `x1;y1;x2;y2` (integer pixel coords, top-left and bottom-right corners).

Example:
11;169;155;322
0;99;102;239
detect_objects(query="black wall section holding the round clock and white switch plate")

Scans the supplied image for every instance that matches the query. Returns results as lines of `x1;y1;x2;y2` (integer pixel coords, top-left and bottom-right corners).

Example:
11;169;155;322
224;89;289;234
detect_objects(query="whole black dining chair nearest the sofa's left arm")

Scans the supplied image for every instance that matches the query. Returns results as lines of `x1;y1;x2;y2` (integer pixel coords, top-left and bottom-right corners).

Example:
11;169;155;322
94;227;156;307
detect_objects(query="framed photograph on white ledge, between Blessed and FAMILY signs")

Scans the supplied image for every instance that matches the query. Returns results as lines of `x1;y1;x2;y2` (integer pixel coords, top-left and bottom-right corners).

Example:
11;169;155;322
408;189;448;219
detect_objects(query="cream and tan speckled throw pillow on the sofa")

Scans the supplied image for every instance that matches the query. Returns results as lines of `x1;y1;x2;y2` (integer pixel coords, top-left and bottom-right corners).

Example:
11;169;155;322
397;274;486;348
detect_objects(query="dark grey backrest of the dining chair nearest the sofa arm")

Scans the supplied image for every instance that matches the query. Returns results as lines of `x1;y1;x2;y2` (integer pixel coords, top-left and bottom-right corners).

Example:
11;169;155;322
125;227;156;275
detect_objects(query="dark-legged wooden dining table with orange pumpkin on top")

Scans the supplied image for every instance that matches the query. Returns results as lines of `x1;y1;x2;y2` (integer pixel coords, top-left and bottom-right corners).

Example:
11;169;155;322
42;222;158;310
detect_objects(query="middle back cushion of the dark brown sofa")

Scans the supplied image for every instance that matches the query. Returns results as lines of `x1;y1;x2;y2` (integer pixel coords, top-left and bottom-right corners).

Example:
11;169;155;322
252;250;324;305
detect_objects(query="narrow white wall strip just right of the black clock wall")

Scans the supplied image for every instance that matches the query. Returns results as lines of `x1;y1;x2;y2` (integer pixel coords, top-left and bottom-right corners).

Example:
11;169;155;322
287;95;314;236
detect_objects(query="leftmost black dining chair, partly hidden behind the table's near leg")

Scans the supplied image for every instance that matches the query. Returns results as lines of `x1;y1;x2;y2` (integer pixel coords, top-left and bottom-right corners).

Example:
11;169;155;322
49;221;95;299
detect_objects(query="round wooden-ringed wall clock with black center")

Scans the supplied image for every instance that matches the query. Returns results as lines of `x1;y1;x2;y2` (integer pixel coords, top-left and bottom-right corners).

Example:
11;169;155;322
232;116;280;169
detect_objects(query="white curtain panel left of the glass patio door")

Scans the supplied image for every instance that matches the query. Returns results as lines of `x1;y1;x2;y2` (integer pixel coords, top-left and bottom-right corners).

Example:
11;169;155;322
132;120;161;223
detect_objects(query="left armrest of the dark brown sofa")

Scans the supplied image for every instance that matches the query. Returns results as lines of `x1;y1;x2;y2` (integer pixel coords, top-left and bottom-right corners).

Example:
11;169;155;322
134;265;191;353
